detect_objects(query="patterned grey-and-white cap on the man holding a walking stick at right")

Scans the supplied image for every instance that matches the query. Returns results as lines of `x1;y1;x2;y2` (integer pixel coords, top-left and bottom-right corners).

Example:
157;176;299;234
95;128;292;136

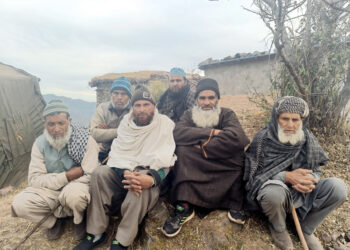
275;96;309;118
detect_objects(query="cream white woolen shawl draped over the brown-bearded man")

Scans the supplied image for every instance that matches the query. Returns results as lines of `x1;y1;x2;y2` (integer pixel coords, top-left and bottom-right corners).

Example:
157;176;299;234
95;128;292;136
107;109;176;170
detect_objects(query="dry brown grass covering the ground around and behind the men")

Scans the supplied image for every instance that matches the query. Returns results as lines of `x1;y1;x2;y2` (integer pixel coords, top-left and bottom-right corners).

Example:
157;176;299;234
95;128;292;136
0;96;350;250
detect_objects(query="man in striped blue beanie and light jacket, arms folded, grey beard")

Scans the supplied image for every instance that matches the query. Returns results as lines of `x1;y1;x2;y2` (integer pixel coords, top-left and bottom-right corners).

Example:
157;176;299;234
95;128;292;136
90;76;132;162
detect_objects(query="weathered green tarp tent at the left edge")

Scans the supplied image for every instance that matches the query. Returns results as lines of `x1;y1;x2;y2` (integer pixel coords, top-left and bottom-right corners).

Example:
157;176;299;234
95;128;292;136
0;63;45;188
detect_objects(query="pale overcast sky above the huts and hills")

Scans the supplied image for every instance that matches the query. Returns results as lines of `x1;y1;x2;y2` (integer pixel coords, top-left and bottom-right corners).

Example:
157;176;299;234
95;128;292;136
0;0;268;101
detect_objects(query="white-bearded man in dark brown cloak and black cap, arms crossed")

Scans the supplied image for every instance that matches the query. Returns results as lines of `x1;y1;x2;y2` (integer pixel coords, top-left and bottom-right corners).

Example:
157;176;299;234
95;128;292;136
162;78;249;237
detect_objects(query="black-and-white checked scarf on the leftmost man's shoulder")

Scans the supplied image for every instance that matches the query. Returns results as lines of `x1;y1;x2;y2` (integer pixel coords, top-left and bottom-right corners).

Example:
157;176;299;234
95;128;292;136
68;125;90;166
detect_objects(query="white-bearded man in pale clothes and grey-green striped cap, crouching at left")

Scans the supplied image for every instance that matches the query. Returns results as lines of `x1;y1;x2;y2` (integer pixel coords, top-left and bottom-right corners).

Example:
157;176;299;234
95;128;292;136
11;100;99;240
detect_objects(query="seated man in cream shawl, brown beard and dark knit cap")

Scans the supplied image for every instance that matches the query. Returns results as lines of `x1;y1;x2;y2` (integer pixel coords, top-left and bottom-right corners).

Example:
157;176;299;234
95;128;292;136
74;87;176;250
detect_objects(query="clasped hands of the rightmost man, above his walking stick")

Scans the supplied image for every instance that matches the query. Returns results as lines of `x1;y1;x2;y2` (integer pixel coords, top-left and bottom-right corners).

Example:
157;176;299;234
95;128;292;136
286;168;318;194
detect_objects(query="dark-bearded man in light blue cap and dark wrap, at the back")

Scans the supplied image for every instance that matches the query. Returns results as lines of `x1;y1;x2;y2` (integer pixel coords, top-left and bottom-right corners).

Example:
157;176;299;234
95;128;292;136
157;68;195;122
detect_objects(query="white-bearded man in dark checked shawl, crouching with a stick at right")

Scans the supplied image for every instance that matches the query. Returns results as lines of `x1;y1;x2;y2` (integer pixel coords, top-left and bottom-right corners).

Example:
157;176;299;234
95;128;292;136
244;96;347;250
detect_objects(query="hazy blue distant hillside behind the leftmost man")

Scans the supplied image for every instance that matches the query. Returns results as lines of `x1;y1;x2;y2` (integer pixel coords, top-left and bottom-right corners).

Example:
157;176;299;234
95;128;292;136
43;94;96;126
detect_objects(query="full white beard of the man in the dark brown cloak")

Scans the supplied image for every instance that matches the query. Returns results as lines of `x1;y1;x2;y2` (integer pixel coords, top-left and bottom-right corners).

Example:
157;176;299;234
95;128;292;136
192;105;221;128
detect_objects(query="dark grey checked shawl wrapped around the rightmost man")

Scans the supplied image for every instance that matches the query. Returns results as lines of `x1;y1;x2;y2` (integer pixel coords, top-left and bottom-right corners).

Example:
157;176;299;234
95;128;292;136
244;98;328;201
